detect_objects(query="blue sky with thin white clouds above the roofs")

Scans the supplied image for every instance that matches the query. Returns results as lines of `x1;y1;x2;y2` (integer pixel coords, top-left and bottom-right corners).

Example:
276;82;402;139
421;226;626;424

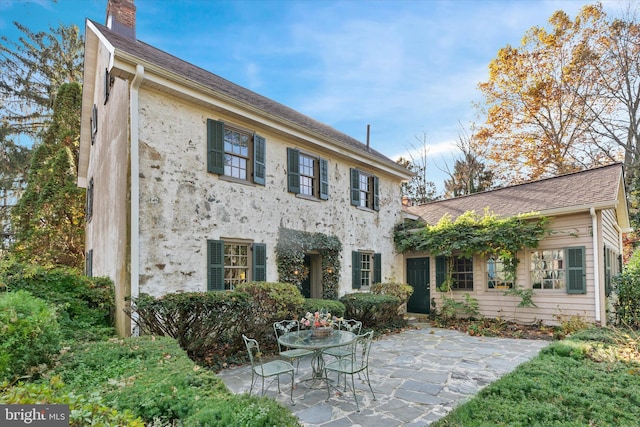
0;0;627;193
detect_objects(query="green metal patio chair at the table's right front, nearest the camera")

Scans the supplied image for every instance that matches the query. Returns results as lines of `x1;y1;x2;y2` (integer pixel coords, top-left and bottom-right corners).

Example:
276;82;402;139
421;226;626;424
324;331;376;412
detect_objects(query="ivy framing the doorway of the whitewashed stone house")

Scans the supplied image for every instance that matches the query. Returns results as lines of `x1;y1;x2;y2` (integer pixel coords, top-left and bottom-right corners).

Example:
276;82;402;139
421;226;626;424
276;228;342;299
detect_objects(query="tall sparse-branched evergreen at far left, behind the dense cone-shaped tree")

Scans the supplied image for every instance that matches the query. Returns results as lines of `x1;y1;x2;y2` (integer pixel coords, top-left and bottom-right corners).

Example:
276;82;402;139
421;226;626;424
0;22;84;254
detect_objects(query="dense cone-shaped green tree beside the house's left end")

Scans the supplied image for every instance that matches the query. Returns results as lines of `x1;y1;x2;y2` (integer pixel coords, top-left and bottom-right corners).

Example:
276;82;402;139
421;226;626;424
11;83;85;268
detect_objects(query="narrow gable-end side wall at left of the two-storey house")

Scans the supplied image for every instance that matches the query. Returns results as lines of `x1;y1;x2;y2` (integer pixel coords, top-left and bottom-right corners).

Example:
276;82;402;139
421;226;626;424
78;24;131;335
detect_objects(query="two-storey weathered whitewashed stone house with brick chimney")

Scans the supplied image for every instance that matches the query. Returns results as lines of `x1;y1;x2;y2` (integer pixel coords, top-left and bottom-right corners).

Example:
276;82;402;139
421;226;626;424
78;0;411;335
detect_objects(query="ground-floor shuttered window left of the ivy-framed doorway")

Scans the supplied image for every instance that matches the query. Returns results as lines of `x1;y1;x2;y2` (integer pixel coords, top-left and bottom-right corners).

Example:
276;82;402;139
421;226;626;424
207;240;267;291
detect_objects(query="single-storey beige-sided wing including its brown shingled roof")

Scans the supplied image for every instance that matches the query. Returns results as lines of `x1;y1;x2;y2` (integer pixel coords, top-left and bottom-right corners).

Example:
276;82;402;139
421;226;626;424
404;164;631;325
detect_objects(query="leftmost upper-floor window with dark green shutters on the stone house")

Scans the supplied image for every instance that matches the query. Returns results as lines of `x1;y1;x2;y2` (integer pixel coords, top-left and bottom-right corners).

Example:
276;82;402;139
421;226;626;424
207;119;266;185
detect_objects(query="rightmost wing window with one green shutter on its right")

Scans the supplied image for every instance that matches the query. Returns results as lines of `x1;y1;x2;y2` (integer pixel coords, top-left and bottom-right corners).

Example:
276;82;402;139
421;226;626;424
529;246;587;294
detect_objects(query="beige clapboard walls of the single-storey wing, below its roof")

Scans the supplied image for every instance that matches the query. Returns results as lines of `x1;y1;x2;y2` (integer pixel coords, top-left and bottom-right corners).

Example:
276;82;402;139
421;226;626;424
424;209;622;325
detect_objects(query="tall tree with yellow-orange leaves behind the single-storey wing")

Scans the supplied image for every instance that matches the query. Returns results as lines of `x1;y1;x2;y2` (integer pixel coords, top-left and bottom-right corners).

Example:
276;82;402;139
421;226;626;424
477;4;640;183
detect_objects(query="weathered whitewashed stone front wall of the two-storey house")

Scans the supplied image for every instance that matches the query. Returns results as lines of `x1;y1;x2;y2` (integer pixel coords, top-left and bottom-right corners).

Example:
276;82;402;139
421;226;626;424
139;87;404;295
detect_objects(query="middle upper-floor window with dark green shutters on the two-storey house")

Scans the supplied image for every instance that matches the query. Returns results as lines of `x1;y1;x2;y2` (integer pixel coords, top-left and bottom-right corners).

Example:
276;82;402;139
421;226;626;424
287;148;329;200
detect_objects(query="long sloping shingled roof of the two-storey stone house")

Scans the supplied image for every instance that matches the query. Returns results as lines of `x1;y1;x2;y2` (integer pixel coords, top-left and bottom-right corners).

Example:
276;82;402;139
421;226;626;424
87;20;410;171
